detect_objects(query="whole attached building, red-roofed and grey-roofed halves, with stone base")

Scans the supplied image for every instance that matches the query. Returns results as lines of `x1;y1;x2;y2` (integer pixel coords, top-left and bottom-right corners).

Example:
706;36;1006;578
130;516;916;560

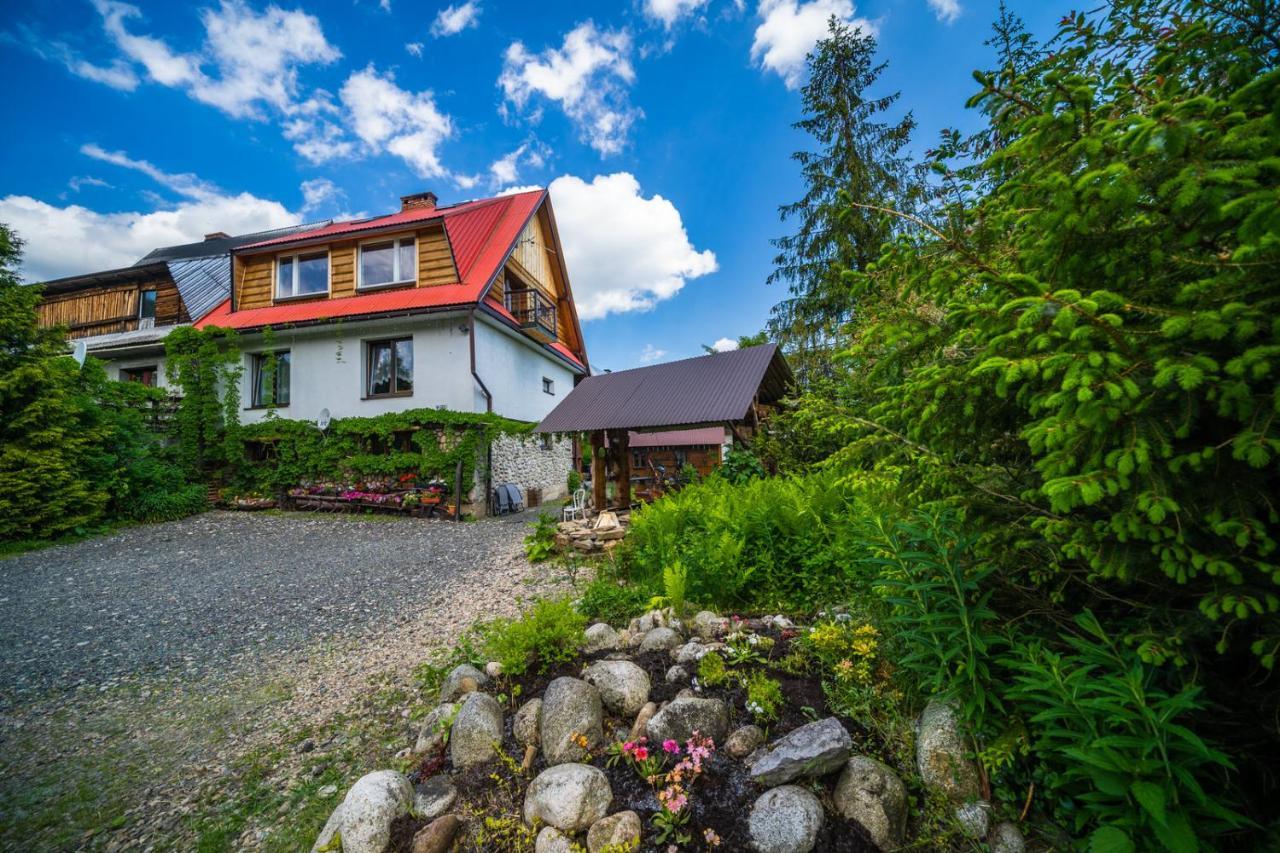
31;190;589;508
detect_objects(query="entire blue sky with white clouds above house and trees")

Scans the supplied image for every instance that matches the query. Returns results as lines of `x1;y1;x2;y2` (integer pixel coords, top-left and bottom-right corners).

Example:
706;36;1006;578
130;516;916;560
0;0;1069;369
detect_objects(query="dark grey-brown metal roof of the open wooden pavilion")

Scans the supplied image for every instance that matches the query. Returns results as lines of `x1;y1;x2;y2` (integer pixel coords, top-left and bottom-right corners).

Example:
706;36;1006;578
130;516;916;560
536;343;792;433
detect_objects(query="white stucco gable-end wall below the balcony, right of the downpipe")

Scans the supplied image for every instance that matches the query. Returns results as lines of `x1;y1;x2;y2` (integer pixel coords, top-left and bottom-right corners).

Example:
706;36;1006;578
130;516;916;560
467;316;573;421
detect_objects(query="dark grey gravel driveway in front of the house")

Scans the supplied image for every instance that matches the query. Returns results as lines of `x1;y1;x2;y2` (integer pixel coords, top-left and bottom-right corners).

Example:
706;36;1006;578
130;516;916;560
0;512;526;708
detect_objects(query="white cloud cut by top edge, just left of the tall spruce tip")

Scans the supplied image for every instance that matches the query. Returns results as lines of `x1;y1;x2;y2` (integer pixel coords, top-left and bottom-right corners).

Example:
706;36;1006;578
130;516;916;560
751;0;870;88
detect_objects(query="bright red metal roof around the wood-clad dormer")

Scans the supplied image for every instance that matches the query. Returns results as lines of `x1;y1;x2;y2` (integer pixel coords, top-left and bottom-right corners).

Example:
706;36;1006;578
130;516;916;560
196;190;545;333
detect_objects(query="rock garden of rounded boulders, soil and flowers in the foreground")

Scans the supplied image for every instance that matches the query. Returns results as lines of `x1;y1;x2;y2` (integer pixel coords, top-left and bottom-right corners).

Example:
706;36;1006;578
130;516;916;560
314;602;1025;853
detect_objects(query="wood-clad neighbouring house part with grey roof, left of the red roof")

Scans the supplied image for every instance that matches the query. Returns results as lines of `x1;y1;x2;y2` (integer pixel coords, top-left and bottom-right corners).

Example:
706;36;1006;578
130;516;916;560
37;224;330;387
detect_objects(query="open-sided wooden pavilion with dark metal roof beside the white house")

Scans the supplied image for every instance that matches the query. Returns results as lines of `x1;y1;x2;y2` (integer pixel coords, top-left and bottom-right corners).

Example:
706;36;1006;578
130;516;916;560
535;343;795;510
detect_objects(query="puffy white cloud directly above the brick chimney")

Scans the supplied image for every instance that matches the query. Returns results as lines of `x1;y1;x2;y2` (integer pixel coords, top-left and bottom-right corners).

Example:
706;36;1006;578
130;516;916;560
340;65;453;178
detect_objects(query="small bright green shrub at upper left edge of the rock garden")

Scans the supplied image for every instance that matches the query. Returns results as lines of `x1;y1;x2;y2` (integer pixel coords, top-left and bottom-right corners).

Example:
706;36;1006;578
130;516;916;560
484;598;586;675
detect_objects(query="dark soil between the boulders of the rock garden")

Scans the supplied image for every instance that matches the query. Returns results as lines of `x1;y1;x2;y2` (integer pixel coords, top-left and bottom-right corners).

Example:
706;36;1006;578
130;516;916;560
388;629;878;853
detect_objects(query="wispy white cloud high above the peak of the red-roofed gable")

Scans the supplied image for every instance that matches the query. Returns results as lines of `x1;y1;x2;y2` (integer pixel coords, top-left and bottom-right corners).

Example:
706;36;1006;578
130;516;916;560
498;20;640;156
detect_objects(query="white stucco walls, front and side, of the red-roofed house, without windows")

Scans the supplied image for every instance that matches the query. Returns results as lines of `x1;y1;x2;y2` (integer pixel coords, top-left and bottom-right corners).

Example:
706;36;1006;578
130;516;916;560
241;313;573;424
